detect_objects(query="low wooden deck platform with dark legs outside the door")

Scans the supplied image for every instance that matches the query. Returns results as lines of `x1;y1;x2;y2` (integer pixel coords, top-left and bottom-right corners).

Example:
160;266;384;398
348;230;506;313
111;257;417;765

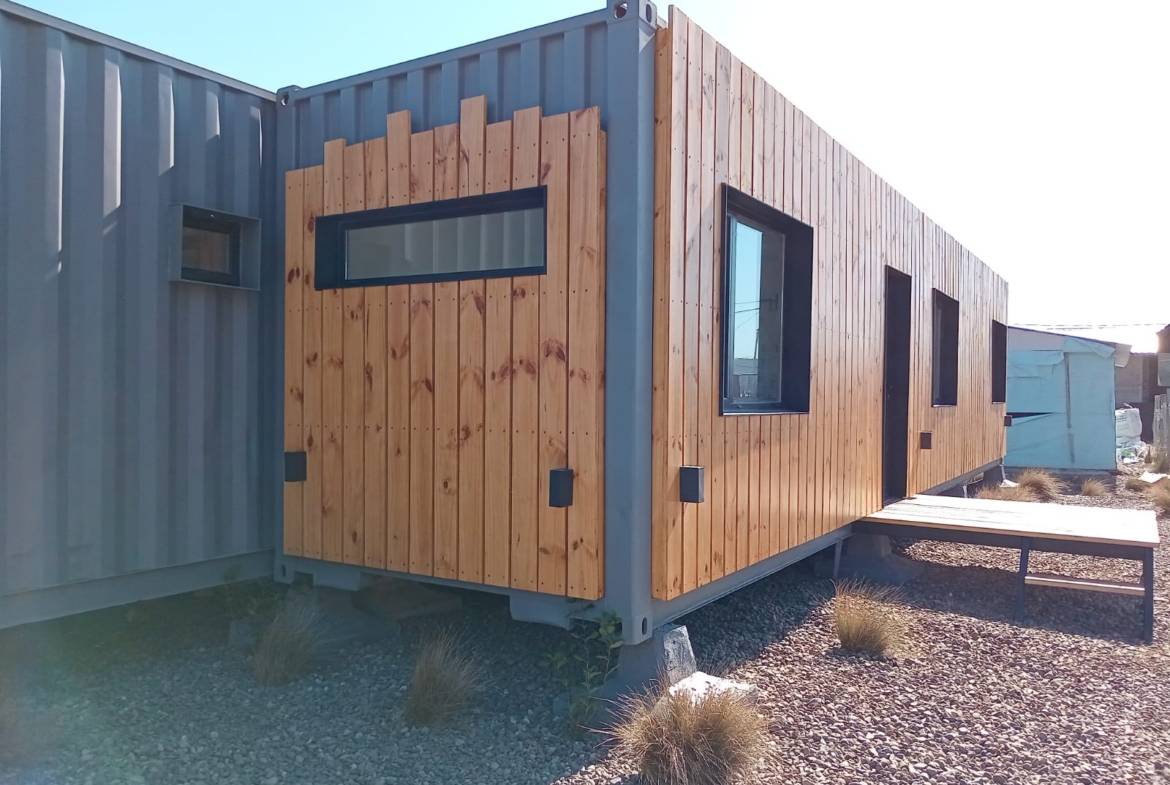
853;496;1158;641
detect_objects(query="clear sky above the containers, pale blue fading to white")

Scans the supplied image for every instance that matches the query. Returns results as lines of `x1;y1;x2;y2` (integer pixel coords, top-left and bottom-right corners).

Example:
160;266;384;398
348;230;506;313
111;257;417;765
18;0;1170;351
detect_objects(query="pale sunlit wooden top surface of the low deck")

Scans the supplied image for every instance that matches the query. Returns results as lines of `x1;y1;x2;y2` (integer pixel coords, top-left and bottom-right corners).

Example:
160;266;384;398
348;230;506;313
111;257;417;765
863;496;1158;548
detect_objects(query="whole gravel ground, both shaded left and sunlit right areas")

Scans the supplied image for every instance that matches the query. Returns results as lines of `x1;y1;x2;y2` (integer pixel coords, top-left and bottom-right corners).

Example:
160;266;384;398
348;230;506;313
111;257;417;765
0;486;1170;785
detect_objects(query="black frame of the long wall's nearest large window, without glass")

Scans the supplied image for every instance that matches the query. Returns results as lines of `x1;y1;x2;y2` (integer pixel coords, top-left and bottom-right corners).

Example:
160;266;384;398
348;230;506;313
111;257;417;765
720;183;814;415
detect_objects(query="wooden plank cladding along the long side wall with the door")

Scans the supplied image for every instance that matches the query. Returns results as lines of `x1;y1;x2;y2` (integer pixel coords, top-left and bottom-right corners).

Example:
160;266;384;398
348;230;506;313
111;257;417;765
651;7;1007;599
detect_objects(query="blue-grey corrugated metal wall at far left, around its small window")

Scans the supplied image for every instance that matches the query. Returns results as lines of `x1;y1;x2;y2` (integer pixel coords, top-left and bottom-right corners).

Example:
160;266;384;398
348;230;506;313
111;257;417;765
0;5;280;603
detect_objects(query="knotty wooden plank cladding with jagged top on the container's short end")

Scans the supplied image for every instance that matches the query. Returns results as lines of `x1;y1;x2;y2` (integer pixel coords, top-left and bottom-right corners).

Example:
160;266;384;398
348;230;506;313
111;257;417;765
284;96;605;599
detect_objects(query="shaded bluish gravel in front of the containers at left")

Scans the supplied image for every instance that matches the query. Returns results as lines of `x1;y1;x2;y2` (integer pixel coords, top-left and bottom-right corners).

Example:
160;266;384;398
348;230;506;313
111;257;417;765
0;594;594;785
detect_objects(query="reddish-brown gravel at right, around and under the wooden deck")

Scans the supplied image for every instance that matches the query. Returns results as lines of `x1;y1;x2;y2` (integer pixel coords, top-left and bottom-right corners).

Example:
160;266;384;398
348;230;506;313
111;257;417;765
563;480;1170;785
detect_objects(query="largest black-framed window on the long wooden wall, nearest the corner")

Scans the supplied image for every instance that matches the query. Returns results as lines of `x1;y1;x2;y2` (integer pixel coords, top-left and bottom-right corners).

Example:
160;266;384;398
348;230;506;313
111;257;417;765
721;185;813;414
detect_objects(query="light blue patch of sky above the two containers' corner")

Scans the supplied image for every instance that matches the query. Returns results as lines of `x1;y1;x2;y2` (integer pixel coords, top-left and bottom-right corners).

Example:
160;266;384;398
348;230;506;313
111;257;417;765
25;0;603;90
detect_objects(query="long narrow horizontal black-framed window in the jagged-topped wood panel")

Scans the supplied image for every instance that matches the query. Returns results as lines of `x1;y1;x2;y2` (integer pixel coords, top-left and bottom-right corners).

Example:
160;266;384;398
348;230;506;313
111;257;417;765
315;186;546;289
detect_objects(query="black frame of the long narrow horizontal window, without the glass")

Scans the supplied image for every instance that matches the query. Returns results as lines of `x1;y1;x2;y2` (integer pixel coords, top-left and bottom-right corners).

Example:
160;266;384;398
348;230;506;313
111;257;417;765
314;185;549;290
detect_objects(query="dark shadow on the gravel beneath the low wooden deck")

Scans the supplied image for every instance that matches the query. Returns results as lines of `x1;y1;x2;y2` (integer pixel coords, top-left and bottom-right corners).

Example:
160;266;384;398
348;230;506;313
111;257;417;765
902;556;1142;643
